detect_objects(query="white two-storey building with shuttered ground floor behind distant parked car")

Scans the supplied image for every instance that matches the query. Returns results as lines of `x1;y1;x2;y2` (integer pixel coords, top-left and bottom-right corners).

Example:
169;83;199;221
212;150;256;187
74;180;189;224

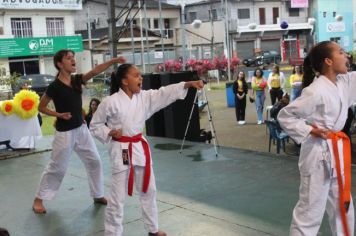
185;0;314;62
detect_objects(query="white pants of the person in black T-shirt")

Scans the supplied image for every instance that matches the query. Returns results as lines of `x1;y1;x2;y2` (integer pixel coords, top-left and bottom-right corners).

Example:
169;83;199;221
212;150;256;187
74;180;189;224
36;124;104;200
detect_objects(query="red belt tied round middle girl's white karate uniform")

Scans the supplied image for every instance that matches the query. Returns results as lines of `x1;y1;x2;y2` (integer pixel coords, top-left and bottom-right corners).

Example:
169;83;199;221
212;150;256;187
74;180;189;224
112;134;151;196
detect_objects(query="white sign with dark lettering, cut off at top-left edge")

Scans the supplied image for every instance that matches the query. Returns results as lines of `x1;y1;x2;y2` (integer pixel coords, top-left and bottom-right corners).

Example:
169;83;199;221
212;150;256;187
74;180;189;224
0;0;82;10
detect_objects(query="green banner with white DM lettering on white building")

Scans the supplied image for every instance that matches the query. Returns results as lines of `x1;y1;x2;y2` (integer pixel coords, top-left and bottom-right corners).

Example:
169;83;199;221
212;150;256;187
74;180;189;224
0;36;83;58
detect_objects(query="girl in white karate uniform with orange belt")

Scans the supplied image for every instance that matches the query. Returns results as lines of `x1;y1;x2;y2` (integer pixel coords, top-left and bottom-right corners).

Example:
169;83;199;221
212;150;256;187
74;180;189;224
278;41;356;236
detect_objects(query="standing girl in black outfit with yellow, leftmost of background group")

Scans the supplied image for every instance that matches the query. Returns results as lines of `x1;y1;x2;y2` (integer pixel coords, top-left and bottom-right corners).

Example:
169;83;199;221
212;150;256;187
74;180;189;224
232;71;248;125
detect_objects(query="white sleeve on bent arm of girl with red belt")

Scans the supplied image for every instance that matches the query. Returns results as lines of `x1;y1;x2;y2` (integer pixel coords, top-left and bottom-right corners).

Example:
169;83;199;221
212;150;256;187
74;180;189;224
90;99;111;143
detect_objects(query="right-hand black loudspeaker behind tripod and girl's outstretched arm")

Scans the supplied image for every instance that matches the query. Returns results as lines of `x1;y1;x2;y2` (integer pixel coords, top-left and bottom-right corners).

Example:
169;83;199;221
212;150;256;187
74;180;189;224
160;71;200;141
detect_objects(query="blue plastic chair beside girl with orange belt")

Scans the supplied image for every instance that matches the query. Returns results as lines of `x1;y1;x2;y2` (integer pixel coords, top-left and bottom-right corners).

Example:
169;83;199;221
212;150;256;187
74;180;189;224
265;120;289;153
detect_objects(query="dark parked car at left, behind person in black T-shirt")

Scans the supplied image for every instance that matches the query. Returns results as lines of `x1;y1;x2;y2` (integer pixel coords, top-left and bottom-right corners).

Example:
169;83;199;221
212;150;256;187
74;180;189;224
17;74;56;97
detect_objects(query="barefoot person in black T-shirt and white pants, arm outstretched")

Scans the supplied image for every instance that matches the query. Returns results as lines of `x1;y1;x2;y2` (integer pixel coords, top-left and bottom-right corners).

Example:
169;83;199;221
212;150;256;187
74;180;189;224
32;50;125;214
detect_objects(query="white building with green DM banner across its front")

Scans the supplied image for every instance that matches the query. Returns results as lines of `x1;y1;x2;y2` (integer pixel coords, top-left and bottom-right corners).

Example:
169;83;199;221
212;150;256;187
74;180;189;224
0;0;83;76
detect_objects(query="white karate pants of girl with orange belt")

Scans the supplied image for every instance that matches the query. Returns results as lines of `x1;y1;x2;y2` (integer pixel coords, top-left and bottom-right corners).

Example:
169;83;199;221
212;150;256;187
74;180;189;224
290;161;354;236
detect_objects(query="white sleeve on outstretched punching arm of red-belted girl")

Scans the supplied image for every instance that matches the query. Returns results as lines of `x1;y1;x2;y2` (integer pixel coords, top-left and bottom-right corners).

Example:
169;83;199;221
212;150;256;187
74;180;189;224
143;82;188;119
